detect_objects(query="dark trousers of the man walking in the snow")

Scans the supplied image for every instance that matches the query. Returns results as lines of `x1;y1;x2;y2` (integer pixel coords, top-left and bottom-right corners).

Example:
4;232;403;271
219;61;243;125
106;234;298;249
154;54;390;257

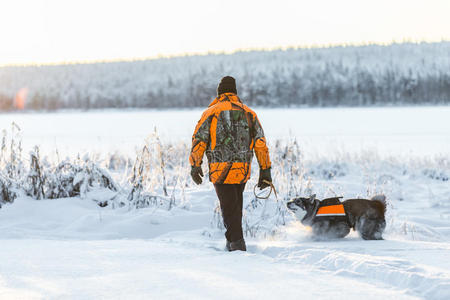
214;183;245;242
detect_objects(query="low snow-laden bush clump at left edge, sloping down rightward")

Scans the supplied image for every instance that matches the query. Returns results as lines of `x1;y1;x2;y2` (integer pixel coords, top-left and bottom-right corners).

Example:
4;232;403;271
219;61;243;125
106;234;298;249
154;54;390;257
0;123;120;203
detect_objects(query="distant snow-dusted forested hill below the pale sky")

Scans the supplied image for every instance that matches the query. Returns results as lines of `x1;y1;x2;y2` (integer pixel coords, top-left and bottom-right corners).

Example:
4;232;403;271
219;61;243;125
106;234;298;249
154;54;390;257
0;42;450;110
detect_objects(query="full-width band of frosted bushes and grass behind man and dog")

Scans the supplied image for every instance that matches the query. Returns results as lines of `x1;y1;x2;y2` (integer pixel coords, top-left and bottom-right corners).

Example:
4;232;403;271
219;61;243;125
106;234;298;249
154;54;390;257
0;123;450;243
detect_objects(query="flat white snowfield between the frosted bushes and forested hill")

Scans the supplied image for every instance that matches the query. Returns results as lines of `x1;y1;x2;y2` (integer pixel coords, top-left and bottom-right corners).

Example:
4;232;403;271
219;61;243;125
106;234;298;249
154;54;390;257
0;106;450;156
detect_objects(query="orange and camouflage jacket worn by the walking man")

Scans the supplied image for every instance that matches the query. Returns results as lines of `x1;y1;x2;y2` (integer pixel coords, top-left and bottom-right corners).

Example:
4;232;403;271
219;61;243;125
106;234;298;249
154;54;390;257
189;93;271;184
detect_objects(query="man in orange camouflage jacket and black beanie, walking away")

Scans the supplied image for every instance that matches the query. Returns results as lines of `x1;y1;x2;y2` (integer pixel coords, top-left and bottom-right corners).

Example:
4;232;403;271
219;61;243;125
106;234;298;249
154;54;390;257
189;76;272;251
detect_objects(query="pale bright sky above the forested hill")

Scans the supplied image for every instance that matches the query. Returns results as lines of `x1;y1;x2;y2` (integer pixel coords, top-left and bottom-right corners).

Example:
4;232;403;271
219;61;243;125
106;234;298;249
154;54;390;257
0;0;450;64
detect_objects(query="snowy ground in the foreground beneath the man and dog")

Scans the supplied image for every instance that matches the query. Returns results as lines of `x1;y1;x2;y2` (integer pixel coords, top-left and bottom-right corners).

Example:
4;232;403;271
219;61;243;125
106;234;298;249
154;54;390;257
0;189;450;299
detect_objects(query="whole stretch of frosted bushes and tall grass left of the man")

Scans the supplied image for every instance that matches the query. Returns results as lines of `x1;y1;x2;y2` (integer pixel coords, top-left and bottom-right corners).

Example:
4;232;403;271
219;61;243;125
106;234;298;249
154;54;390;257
0;124;189;210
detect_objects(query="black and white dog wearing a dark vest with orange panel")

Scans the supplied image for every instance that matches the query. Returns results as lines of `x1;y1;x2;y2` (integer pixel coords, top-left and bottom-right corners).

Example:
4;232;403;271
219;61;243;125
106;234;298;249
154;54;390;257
287;195;386;240
